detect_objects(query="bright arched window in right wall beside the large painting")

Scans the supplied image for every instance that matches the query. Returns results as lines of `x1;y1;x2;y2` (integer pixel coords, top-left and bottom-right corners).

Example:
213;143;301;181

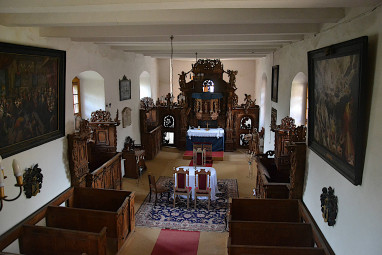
289;72;308;126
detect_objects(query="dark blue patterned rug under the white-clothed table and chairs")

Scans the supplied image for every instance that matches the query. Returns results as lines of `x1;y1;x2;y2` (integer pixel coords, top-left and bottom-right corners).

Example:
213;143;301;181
135;176;239;232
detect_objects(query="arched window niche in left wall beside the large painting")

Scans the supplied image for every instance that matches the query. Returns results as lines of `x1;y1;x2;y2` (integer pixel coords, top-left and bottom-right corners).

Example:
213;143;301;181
72;71;105;119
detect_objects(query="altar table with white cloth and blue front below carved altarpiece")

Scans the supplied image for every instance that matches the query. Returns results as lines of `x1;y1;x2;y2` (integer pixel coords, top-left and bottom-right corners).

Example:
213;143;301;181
186;128;224;151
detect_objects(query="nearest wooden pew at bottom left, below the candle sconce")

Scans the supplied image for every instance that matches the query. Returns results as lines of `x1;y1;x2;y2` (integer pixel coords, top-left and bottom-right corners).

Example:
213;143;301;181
19;225;106;255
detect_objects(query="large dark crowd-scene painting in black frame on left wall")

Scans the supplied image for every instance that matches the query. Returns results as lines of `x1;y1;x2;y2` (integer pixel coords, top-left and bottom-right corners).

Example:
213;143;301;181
0;43;66;157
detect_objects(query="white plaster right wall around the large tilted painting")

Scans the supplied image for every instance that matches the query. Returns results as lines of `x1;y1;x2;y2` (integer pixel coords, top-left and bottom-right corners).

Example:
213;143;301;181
257;5;382;255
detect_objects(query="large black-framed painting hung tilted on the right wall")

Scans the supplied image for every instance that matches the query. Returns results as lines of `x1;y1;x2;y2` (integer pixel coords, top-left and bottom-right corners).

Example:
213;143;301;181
308;37;368;185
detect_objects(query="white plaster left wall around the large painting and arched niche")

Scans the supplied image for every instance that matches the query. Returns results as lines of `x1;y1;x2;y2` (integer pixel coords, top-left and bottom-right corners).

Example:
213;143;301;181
0;23;158;239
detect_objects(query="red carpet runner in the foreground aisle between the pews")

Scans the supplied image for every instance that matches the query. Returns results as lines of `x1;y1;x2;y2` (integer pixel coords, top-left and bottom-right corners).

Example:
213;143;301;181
151;229;200;255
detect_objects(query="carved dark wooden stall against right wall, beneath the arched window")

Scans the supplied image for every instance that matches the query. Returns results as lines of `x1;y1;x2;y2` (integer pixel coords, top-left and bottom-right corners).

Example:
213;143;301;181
256;117;306;199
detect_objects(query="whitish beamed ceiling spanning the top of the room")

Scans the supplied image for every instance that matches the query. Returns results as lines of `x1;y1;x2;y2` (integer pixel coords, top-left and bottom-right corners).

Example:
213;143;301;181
0;0;381;58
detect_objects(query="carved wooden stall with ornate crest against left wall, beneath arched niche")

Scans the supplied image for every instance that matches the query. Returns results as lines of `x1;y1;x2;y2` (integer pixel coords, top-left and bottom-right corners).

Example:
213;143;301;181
68;111;122;190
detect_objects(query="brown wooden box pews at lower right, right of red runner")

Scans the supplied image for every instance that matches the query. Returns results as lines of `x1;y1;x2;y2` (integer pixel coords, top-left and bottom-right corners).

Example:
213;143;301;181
227;199;334;255
